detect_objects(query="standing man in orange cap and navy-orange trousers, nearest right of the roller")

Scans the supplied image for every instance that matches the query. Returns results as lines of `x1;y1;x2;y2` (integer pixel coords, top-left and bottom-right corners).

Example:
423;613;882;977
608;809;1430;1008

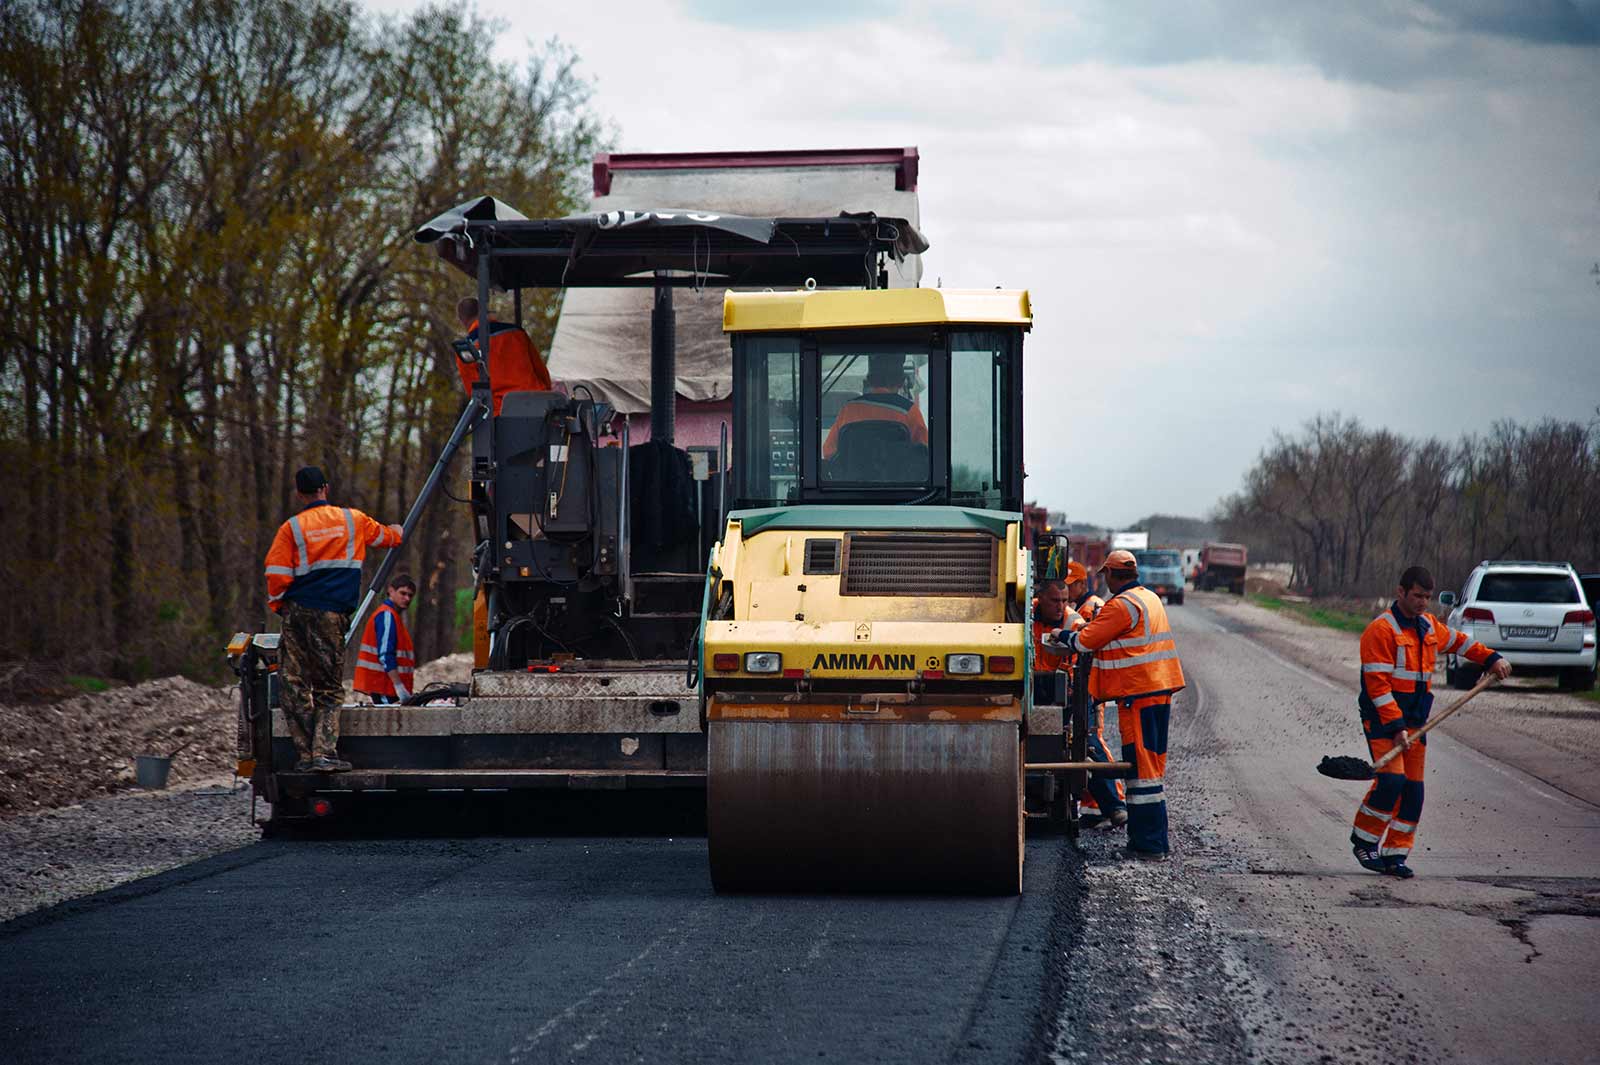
1054;550;1184;860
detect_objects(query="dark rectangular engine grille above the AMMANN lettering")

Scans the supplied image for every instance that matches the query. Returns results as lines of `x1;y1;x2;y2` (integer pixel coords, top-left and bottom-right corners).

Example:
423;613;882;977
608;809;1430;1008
838;533;995;596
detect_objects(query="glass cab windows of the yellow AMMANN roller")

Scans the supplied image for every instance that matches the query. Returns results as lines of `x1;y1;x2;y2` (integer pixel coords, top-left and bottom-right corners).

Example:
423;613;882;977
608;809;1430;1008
734;329;1021;509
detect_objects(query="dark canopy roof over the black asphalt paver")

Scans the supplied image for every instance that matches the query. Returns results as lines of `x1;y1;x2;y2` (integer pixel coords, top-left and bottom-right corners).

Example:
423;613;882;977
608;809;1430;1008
414;197;928;289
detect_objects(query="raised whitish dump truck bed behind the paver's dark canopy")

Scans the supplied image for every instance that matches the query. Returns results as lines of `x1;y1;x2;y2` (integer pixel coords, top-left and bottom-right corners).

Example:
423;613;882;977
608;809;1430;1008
549;165;922;413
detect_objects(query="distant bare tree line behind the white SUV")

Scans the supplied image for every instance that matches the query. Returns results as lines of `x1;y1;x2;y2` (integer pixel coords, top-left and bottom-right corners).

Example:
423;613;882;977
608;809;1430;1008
1214;414;1600;596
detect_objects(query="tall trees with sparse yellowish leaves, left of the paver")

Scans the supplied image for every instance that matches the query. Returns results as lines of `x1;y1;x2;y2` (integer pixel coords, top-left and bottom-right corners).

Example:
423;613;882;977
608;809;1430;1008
0;0;605;678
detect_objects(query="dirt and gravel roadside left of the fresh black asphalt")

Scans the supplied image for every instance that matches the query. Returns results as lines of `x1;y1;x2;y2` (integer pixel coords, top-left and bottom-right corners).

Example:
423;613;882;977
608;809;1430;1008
0;654;472;921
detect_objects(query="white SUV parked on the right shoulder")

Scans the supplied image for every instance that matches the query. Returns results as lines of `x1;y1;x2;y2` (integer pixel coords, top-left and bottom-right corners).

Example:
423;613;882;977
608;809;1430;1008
1438;561;1595;691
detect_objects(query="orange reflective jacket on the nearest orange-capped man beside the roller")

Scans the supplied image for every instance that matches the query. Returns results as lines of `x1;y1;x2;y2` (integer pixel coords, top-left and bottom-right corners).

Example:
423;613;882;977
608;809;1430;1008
1078;585;1184;700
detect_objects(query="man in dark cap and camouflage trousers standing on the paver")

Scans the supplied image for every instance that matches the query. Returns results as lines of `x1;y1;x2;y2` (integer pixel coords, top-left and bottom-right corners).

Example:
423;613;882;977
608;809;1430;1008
266;465;402;772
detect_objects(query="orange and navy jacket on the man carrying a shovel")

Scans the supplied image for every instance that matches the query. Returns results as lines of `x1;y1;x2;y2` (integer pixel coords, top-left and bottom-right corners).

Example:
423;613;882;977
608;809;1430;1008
1357;603;1499;737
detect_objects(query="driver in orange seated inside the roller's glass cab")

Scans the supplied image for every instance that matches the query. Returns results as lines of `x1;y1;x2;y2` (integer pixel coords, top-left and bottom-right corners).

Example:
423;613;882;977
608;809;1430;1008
822;352;928;480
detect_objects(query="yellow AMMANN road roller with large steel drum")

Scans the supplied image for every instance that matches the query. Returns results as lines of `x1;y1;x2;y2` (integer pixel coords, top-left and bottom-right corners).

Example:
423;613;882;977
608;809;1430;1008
694;288;1032;894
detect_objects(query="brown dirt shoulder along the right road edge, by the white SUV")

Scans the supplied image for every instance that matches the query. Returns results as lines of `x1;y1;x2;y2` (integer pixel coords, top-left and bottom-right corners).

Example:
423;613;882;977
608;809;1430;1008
1190;592;1600;804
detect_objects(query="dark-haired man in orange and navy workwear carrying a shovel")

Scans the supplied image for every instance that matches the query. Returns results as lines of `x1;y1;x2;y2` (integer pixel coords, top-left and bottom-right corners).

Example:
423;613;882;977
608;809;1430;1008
1350;566;1510;880
